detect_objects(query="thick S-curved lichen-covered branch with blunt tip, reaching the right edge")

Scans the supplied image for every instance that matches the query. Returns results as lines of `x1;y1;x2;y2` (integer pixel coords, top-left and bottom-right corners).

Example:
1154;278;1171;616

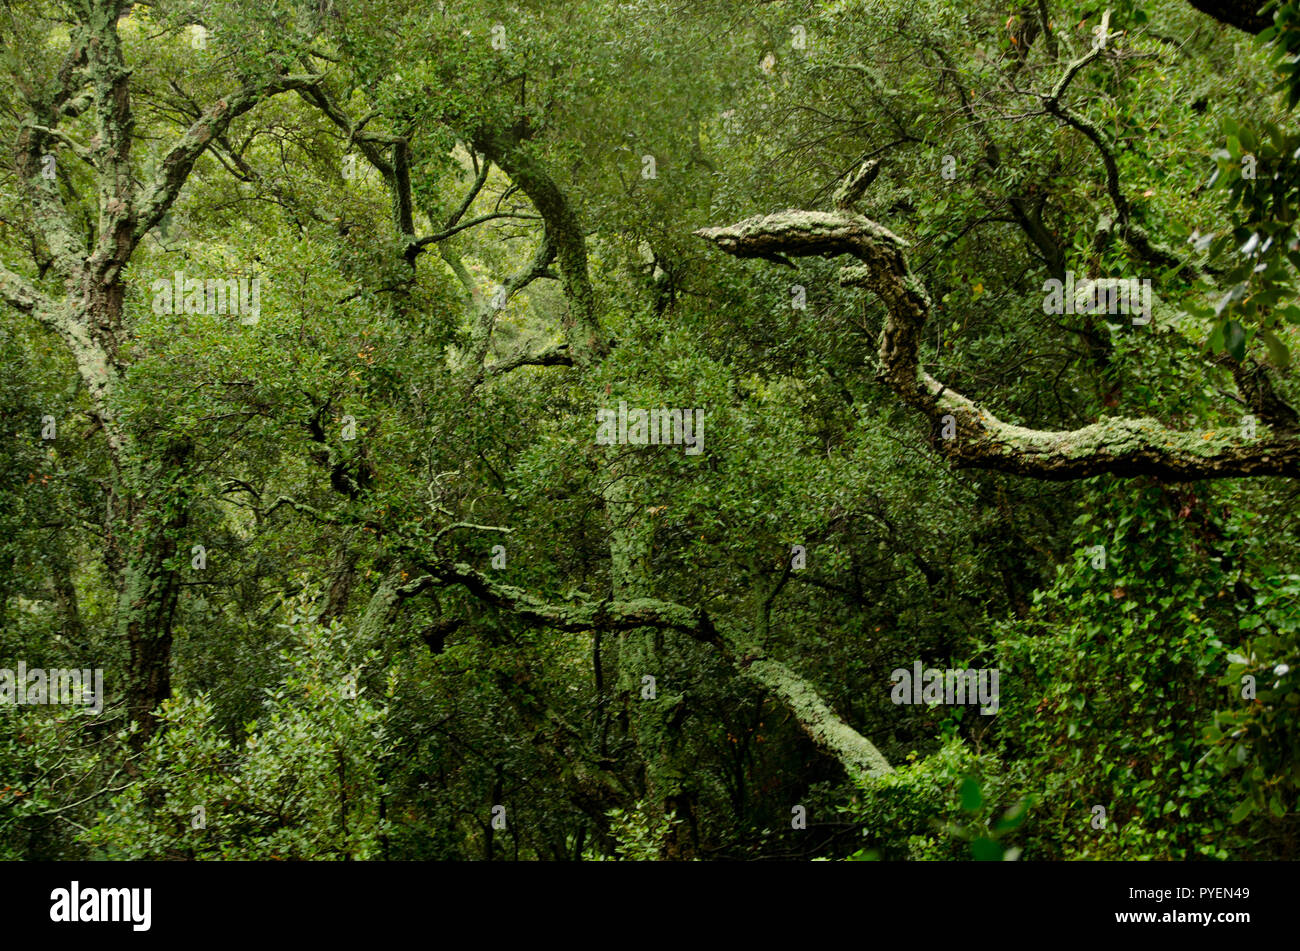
696;209;1300;481
